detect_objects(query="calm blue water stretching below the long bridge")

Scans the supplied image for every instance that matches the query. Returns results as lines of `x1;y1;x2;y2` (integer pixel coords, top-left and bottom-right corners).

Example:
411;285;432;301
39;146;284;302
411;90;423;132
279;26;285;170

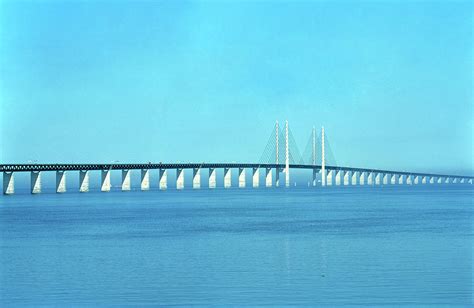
0;187;474;307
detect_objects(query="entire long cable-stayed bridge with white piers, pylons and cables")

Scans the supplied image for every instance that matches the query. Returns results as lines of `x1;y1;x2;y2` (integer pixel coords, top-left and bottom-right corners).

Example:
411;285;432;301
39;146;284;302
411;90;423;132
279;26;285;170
0;121;474;195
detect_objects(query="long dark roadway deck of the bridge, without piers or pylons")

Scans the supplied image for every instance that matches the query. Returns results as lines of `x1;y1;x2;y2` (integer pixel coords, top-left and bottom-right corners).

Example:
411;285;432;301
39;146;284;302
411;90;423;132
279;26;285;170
0;163;474;179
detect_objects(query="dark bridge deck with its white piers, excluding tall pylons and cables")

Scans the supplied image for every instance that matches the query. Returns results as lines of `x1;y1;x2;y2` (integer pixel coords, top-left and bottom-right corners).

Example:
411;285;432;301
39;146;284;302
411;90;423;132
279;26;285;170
0;162;474;195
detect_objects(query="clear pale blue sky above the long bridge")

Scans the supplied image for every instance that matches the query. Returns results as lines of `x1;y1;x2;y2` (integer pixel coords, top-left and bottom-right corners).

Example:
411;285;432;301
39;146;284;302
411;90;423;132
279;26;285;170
0;0;474;174
